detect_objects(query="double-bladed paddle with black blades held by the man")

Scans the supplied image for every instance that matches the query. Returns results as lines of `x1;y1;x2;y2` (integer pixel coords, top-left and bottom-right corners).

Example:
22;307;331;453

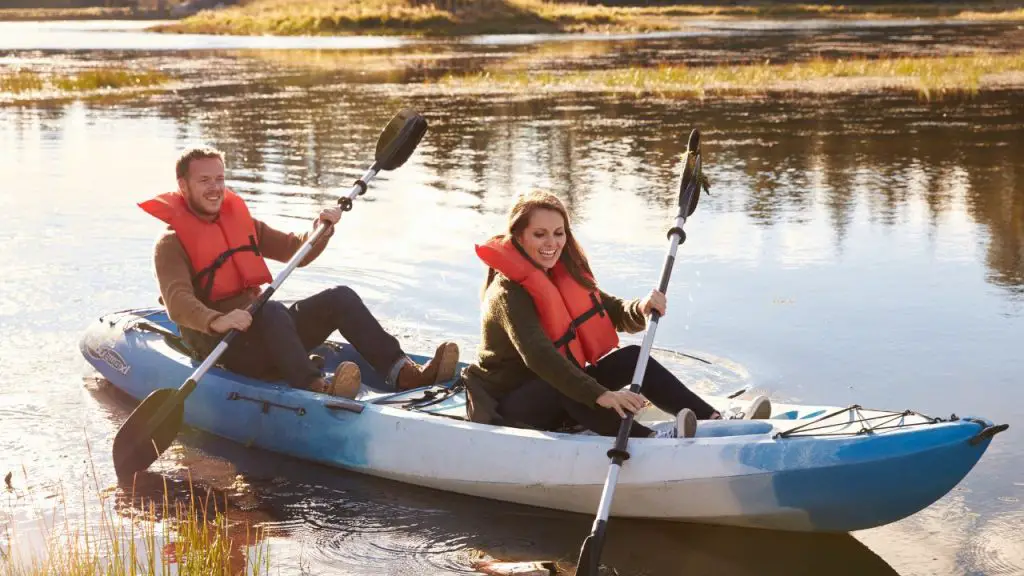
114;110;427;479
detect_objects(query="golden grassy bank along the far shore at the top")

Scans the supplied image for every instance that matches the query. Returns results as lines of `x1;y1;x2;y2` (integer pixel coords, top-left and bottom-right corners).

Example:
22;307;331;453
154;0;1024;36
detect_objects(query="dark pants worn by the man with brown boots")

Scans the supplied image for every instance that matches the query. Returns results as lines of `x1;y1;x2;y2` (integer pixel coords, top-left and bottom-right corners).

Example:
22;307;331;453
220;286;406;388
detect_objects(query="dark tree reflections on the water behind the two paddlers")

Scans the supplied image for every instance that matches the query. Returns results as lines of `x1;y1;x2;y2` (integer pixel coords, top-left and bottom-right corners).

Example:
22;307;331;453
22;82;1007;294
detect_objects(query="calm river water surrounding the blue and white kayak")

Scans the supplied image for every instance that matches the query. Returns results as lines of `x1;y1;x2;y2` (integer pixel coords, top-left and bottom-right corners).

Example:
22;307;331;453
0;17;1024;575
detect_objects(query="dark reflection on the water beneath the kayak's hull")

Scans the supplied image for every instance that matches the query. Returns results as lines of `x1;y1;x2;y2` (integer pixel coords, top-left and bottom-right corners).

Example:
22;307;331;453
130;407;897;576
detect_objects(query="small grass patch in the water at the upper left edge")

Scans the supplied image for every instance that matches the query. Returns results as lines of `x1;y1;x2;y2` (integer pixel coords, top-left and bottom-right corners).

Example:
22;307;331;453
0;68;171;94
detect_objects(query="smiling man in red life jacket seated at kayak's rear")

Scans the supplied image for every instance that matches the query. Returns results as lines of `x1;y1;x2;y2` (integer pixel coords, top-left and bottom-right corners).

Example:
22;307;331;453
139;148;459;398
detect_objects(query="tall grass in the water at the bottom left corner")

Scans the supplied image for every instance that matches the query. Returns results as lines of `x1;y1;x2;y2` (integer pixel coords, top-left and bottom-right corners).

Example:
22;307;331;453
0;463;269;576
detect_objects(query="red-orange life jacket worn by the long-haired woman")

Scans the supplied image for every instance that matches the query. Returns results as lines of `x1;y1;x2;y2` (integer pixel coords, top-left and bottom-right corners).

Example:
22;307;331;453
476;236;618;367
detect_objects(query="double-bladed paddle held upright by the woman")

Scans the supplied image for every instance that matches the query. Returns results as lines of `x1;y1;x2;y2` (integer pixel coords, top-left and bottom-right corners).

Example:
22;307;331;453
575;129;707;576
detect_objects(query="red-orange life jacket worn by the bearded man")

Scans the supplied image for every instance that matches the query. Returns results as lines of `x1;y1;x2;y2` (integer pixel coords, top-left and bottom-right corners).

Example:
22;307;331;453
139;189;273;302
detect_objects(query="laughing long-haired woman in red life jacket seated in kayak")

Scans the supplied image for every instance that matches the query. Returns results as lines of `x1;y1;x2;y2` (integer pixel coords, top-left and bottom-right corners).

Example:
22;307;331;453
464;193;771;438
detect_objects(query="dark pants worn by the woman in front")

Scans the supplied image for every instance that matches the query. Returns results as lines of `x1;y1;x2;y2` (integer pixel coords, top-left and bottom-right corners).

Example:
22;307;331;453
498;345;715;438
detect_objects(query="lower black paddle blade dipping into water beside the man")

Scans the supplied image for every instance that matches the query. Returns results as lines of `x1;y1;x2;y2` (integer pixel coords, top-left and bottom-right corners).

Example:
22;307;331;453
114;388;185;480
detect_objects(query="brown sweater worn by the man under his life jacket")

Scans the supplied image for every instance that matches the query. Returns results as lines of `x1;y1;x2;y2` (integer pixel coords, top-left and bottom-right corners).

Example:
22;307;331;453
153;218;334;358
